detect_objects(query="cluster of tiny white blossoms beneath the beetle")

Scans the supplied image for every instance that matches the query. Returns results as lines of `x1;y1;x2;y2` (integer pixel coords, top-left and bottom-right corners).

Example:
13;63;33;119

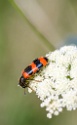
28;46;77;118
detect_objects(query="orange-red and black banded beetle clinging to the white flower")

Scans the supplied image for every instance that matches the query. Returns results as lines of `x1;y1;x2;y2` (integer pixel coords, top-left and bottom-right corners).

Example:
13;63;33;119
19;57;48;88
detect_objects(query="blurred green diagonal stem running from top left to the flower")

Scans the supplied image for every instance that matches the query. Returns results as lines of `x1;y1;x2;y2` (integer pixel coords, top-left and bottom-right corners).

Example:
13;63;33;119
9;0;55;51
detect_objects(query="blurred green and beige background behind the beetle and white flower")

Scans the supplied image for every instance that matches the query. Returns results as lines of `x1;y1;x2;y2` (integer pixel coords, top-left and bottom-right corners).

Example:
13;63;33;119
0;0;77;125
